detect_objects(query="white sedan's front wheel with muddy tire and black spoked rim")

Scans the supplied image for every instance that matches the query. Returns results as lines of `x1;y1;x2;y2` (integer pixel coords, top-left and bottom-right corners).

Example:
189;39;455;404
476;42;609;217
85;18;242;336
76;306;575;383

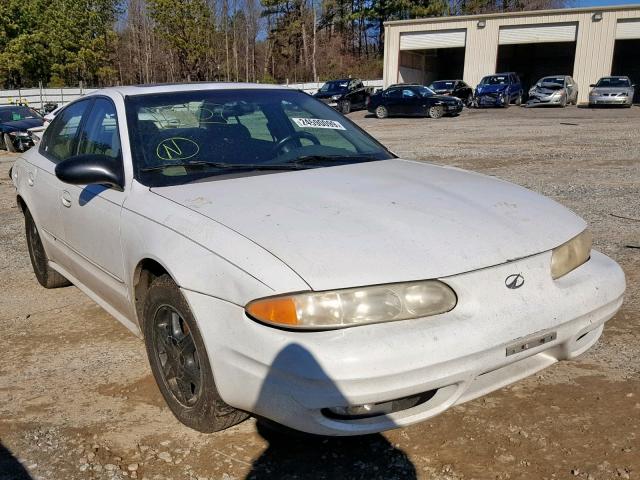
142;275;249;433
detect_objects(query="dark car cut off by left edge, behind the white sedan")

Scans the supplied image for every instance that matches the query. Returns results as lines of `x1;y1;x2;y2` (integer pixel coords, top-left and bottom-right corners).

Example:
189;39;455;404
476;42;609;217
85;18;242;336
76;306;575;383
0;105;44;152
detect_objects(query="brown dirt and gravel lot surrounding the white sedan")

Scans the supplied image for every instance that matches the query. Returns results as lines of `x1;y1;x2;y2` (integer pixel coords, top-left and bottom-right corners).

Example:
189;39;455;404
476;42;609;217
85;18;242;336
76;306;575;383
0;107;640;480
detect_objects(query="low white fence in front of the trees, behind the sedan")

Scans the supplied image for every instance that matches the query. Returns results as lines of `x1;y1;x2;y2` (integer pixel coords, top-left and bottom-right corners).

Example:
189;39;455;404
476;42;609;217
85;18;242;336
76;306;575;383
0;80;382;109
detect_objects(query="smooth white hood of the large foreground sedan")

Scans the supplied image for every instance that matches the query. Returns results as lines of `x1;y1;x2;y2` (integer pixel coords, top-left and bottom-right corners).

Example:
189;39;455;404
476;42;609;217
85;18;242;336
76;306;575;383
151;159;585;290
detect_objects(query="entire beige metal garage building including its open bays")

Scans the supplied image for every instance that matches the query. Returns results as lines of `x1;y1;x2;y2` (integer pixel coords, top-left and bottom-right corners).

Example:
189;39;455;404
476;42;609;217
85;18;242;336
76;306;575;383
384;5;640;102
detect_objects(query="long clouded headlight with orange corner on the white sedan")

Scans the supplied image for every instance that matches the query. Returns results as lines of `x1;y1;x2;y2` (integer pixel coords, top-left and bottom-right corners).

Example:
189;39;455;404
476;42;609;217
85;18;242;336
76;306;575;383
245;280;458;330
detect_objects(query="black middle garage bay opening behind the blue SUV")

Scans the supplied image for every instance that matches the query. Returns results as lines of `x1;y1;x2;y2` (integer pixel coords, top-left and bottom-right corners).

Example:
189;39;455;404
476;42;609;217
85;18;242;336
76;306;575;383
496;42;576;99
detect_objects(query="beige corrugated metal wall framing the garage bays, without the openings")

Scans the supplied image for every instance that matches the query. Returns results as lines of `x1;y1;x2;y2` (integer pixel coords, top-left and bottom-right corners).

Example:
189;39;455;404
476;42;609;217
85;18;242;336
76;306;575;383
384;6;640;102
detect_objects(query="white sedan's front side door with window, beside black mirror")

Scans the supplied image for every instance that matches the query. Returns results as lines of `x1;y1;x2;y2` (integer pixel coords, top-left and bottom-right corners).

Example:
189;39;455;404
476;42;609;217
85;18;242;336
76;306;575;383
61;97;128;313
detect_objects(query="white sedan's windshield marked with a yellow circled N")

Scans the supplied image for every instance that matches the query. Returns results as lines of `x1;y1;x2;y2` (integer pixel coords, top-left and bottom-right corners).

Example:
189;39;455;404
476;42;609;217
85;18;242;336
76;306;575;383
127;89;393;186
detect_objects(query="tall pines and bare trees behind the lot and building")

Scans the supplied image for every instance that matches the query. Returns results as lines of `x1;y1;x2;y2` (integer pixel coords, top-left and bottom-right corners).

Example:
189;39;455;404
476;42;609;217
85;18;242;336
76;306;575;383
0;0;566;88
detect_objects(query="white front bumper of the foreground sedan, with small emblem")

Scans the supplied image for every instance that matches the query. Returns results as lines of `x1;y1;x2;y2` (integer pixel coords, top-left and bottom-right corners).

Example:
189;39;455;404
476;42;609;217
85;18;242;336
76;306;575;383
184;251;625;435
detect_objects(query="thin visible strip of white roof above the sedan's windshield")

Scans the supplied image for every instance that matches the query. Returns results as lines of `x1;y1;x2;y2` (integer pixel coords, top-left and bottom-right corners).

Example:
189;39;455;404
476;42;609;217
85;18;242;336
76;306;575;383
89;82;292;97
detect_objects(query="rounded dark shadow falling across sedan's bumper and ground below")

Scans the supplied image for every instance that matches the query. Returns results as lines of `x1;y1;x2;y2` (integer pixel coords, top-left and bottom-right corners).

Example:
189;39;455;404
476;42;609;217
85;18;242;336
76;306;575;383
246;344;417;480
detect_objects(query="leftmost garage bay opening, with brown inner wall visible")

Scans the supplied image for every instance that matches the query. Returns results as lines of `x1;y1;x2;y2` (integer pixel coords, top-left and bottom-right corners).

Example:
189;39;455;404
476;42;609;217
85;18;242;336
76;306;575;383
398;47;465;85
